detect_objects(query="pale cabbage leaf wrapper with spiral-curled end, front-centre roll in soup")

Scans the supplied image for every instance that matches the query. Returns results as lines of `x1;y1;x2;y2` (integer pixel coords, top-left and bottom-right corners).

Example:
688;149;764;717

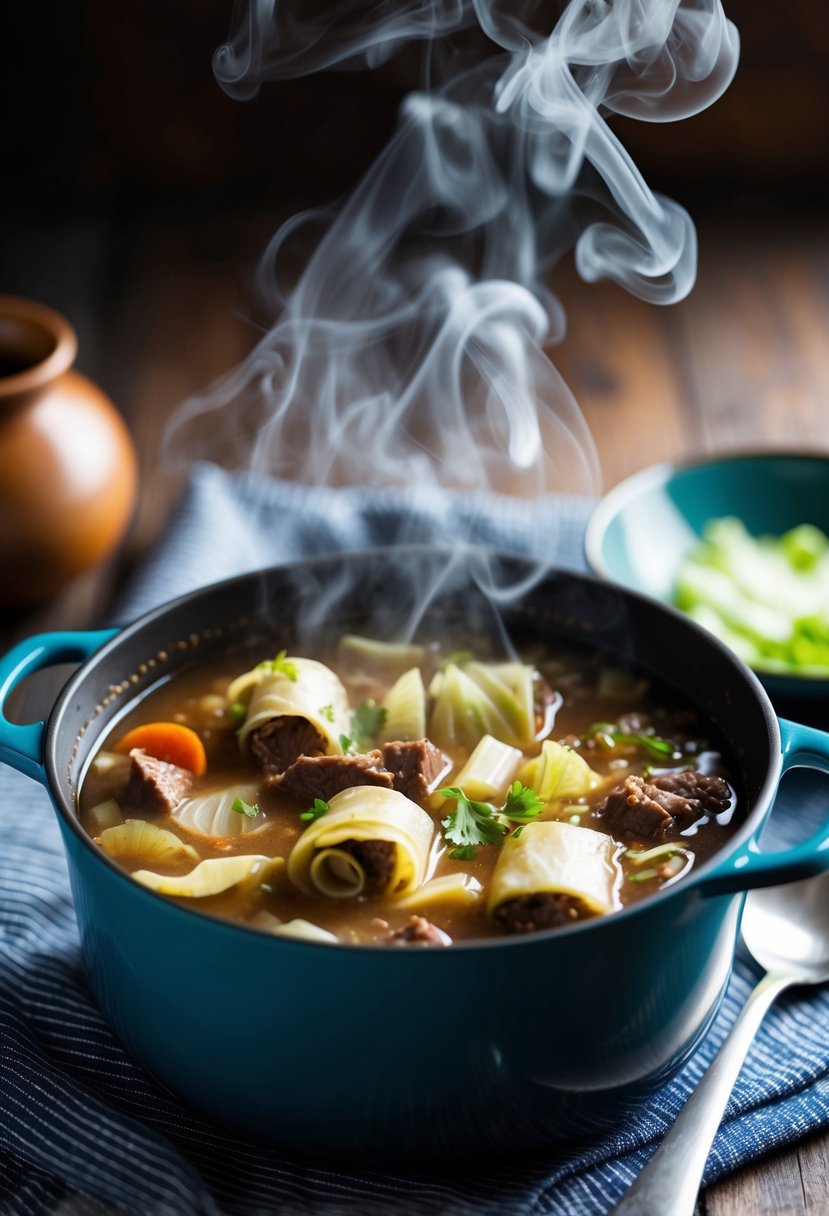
288;786;434;899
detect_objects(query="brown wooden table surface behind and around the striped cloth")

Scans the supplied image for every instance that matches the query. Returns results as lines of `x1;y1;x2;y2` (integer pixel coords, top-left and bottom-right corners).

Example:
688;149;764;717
0;204;829;1216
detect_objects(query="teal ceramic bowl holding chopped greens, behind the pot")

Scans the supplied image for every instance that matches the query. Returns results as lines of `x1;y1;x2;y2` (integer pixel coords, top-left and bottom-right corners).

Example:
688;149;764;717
585;452;829;702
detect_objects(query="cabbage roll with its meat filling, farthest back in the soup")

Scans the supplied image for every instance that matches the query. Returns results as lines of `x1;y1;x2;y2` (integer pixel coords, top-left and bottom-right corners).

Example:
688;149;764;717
227;657;351;771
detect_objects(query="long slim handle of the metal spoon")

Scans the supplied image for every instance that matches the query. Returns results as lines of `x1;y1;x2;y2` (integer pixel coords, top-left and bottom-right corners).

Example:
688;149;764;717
611;973;795;1216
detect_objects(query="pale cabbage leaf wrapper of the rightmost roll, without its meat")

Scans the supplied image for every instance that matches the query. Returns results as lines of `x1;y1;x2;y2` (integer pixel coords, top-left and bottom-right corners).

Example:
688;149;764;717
487;820;622;916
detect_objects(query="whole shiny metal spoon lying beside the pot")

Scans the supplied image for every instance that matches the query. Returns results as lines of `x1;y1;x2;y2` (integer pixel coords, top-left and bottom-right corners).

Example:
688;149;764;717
611;872;829;1216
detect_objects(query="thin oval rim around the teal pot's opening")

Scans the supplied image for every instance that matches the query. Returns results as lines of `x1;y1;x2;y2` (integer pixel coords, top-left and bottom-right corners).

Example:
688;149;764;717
43;544;783;957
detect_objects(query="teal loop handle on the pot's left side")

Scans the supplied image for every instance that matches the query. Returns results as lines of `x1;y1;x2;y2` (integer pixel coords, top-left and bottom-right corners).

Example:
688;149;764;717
0;629;119;784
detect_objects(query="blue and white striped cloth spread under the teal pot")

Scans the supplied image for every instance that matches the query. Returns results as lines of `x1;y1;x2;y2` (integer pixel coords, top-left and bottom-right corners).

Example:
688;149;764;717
0;466;829;1216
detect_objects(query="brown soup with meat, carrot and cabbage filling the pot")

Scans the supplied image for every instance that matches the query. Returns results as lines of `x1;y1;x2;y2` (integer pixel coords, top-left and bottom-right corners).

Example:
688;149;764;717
80;637;740;946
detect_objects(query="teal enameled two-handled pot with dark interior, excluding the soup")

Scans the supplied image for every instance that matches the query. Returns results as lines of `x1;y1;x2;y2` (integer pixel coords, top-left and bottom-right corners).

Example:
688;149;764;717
0;547;829;1161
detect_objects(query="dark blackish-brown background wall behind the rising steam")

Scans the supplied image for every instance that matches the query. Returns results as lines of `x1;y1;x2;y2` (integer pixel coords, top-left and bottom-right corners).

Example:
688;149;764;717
6;0;829;228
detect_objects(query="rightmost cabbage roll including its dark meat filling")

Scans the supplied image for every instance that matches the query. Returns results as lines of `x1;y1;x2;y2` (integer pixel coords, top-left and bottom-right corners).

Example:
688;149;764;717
487;820;621;933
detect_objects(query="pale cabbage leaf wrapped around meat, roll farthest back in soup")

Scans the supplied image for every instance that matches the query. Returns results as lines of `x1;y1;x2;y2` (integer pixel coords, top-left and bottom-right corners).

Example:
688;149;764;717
227;658;351;755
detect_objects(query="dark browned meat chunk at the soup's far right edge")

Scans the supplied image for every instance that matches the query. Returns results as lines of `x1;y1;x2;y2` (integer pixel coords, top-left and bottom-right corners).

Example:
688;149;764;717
598;770;731;840
